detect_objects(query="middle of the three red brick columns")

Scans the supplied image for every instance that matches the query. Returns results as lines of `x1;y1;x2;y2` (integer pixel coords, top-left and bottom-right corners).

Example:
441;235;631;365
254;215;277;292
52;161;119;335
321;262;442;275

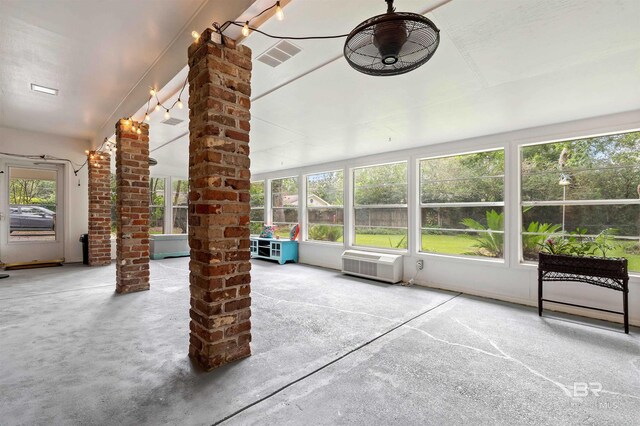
116;119;149;293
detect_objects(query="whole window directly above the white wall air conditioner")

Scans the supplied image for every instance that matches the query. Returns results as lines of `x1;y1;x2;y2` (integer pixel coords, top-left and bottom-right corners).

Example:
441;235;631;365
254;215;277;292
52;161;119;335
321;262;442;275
353;162;407;249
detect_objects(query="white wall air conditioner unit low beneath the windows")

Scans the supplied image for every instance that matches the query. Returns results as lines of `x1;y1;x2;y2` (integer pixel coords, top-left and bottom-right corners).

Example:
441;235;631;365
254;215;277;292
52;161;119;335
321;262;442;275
342;250;403;283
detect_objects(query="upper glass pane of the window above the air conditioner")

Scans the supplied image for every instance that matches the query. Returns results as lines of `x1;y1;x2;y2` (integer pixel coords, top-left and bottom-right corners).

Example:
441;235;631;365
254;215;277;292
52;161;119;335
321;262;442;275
354;162;407;206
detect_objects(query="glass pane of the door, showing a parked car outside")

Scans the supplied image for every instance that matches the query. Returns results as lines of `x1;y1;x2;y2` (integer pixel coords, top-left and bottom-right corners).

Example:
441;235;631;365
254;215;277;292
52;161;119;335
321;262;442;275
9;167;58;241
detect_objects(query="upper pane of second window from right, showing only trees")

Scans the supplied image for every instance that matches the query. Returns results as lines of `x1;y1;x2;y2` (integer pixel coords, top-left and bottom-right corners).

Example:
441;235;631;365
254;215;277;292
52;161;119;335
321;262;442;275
420;150;504;203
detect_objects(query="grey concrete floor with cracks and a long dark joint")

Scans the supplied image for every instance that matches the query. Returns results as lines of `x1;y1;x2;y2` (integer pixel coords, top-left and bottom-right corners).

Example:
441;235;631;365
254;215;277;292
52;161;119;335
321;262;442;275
0;258;640;425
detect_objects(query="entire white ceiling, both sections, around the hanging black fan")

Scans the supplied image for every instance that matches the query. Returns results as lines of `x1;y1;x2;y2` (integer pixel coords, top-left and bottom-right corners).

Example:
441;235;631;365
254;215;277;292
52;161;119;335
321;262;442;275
0;0;640;176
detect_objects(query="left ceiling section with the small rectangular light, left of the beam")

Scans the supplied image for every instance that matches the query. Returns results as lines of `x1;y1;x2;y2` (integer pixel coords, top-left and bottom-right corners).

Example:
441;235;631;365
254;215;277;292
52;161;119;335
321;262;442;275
0;0;206;139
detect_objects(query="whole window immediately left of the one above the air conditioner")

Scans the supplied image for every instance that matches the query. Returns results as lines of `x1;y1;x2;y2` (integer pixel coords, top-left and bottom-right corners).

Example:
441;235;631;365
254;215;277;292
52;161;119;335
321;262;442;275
305;170;344;242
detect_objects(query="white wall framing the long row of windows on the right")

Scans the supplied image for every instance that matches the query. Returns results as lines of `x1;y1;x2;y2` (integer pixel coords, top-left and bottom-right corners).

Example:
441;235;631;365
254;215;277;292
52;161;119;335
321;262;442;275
252;110;640;326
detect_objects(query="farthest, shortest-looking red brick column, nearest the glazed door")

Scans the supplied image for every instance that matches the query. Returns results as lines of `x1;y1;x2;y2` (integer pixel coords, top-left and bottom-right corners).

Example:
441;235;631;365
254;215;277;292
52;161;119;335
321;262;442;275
87;151;111;266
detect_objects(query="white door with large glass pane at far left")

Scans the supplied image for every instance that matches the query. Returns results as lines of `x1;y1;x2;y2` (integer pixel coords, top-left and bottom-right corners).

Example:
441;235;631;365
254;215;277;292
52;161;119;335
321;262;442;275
0;160;64;264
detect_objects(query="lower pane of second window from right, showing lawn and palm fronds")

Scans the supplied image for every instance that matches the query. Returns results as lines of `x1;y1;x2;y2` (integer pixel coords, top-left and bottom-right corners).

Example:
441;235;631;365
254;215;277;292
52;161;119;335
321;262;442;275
421;206;504;258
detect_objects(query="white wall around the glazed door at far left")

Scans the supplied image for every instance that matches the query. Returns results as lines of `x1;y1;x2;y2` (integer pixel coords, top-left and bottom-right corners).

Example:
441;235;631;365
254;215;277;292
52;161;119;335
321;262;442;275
0;127;91;262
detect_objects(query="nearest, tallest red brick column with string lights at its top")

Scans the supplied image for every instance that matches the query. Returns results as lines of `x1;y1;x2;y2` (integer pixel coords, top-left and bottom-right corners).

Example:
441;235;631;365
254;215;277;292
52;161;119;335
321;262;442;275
189;30;251;370
